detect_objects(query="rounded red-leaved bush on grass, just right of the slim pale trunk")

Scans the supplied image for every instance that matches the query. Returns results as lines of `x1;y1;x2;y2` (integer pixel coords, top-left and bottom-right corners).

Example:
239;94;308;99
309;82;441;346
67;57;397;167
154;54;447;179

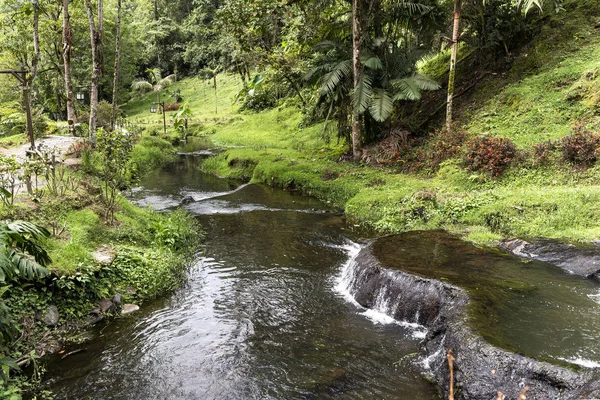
463;136;516;178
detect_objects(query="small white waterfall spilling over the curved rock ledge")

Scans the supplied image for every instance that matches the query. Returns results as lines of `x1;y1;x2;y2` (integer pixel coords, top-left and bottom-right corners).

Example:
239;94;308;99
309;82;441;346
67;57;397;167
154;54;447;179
335;243;427;339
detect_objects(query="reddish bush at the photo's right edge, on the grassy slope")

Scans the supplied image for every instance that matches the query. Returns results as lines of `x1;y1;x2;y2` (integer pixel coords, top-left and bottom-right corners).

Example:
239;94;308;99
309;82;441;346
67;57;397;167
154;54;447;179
560;123;600;168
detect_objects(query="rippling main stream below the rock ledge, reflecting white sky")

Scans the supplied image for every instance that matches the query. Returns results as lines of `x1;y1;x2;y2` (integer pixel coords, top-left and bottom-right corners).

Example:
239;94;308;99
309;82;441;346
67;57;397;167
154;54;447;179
49;142;436;400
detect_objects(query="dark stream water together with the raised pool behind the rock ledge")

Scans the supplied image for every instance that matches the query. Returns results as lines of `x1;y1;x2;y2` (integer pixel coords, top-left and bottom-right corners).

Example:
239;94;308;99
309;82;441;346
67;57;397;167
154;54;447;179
48;140;600;400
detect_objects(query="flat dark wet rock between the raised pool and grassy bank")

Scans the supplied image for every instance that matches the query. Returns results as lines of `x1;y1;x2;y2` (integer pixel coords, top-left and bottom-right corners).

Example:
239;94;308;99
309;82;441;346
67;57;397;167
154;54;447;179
500;239;600;278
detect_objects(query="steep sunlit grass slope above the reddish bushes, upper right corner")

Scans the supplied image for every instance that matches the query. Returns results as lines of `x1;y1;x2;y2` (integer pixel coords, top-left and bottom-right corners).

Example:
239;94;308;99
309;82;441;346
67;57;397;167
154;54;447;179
461;1;600;148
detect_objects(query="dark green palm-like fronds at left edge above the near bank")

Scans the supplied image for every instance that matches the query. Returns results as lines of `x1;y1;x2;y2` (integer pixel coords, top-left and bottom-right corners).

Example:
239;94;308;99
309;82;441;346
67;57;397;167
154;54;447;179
0;221;52;282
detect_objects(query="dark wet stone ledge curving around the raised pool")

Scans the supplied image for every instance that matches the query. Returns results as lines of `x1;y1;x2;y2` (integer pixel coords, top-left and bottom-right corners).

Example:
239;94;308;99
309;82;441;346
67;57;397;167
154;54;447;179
351;242;600;400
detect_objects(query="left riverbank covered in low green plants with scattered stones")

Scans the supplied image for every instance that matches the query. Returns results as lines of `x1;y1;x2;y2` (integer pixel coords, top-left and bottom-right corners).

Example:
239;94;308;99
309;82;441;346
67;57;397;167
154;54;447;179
0;134;202;398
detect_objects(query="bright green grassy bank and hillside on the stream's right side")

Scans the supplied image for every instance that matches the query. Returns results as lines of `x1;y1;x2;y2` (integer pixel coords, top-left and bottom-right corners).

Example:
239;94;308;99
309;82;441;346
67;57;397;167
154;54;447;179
120;1;600;245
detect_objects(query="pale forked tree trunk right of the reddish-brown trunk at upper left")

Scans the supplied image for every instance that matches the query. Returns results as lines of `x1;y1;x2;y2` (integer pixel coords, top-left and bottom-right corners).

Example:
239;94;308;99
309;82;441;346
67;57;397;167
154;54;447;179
85;0;104;146
